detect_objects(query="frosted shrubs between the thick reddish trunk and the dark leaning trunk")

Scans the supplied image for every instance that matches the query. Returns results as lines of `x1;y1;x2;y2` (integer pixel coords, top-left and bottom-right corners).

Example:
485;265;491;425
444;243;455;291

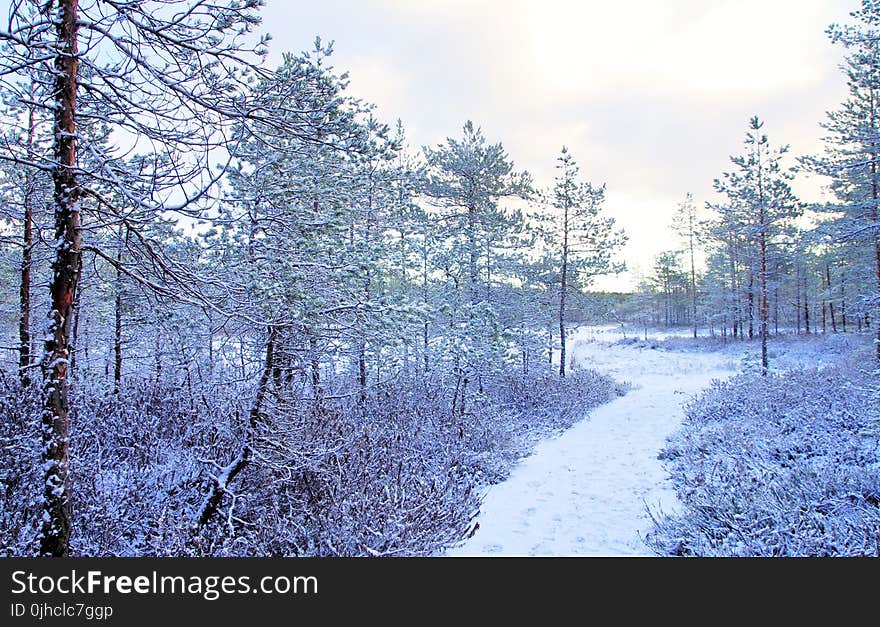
70;380;248;556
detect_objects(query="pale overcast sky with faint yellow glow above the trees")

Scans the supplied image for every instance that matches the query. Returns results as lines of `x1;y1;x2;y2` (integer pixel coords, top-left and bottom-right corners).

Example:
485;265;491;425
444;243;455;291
263;0;859;287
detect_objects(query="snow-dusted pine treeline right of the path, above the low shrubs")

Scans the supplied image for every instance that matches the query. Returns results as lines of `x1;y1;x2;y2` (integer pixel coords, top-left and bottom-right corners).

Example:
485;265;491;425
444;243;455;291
629;2;880;371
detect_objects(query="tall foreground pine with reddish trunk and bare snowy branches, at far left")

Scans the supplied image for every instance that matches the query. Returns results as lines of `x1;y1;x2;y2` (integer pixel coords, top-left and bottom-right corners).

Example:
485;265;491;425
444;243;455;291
0;0;262;556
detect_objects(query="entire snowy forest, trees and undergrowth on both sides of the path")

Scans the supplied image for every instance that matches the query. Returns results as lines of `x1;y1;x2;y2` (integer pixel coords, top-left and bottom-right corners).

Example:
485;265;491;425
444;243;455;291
0;0;880;556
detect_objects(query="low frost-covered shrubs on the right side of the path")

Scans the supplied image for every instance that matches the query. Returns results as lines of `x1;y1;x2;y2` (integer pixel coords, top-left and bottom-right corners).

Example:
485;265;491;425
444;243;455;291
648;362;880;556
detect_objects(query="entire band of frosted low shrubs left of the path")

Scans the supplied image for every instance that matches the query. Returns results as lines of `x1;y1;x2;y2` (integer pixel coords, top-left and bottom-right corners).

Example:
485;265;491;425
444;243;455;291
0;360;622;556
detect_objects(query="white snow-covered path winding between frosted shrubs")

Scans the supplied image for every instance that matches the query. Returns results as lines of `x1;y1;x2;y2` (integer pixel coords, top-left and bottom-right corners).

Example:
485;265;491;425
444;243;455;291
446;330;738;556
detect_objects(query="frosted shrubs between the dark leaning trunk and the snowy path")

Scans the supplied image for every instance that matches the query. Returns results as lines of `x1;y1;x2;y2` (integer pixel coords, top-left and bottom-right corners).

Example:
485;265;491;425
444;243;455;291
190;371;621;556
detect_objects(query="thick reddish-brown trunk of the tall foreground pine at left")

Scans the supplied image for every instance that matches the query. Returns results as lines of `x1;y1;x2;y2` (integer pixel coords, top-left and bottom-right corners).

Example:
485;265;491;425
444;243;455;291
40;0;82;557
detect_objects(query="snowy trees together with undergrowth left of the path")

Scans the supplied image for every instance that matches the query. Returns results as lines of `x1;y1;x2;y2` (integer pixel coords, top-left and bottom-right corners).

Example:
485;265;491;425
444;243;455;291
0;0;623;555
